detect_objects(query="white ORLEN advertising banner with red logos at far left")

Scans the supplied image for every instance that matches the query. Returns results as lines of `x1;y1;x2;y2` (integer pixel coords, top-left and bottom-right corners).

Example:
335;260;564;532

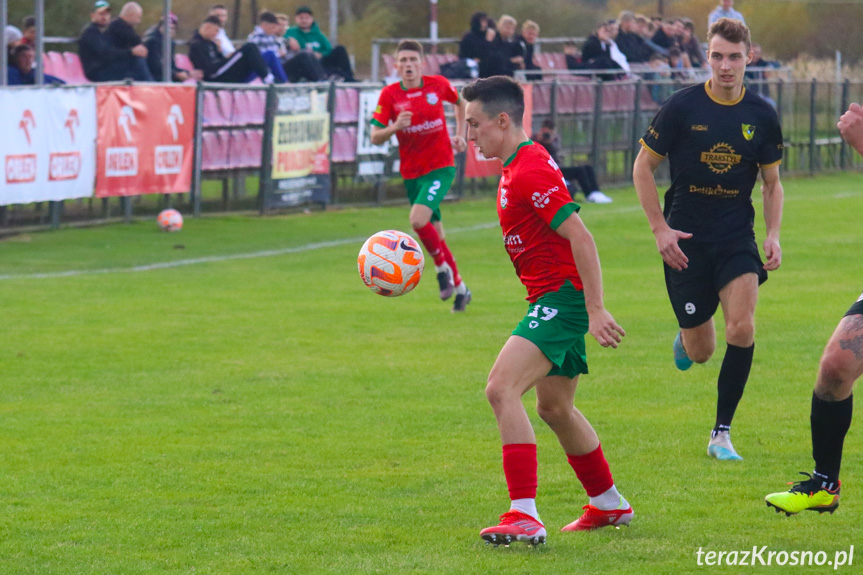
0;87;96;206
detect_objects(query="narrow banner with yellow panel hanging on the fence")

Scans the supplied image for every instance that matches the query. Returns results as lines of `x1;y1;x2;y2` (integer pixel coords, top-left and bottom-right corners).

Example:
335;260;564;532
266;88;330;208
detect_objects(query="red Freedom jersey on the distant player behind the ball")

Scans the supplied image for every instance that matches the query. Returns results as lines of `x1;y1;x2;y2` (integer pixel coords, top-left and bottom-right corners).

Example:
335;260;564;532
371;76;459;180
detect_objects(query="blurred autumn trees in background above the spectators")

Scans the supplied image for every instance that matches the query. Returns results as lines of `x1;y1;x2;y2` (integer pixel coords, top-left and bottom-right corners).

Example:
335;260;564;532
9;0;863;68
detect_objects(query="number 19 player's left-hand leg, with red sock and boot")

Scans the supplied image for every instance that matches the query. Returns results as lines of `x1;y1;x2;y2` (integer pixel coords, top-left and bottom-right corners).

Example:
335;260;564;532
480;335;551;545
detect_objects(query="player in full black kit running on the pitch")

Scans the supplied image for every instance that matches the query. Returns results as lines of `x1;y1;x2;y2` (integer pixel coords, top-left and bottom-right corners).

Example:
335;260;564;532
633;18;783;461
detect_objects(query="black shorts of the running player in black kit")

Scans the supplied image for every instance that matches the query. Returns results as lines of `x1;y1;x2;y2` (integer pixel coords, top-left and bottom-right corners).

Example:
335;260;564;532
665;237;767;328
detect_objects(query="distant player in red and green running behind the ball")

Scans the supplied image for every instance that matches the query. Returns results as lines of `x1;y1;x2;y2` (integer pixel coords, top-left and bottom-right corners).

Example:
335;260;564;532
371;40;471;312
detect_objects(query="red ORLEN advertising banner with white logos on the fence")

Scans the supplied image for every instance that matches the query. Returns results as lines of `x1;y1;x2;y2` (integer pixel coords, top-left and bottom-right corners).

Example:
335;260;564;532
96;82;195;198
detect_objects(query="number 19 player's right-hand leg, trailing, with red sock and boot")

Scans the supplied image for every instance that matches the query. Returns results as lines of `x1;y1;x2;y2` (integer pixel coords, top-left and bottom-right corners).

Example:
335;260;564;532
536;376;635;531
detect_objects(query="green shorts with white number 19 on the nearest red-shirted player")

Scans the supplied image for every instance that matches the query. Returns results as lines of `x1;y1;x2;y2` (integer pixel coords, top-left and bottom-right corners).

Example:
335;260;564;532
512;281;590;378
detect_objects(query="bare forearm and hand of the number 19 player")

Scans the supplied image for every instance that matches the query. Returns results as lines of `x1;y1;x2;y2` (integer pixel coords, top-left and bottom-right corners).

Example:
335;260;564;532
555;212;626;347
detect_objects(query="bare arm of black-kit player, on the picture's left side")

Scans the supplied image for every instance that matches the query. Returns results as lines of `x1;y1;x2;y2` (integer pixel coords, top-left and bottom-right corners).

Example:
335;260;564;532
632;146;692;270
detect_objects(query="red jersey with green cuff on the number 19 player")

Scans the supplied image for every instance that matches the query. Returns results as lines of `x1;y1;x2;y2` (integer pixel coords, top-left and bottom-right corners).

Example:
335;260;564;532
497;141;584;302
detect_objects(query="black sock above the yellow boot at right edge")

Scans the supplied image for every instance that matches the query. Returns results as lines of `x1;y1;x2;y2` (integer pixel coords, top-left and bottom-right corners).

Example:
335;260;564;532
809;393;854;483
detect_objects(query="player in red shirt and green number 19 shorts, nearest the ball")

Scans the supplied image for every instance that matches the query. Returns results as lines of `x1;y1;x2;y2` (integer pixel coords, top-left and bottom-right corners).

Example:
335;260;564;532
462;76;634;544
